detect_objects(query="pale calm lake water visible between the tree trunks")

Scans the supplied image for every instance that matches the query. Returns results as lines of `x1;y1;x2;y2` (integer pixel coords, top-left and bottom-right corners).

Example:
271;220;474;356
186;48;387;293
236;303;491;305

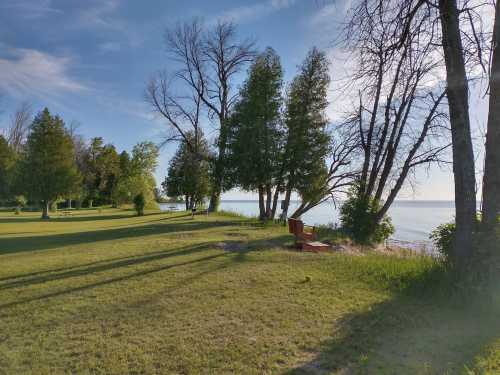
161;201;455;242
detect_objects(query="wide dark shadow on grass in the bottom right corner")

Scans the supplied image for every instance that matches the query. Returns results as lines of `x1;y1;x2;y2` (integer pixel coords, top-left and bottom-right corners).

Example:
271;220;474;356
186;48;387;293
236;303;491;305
285;286;500;375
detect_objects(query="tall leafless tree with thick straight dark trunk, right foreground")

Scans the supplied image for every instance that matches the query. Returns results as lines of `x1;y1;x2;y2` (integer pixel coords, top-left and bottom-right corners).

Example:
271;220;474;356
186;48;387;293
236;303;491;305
344;0;488;265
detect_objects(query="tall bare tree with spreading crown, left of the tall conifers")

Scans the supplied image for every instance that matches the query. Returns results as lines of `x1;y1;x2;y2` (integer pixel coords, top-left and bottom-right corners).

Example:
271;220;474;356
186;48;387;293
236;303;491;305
148;19;255;211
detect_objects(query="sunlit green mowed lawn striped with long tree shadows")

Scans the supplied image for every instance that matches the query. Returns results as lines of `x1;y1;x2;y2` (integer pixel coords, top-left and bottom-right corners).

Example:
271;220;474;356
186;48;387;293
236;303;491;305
0;209;500;375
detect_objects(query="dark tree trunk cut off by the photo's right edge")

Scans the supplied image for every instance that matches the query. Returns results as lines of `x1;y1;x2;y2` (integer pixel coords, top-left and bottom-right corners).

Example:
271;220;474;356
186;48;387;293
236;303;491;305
482;1;500;234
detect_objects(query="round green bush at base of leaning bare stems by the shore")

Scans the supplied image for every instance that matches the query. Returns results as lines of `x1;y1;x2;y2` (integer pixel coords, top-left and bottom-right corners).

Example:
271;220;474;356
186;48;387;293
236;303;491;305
340;189;394;245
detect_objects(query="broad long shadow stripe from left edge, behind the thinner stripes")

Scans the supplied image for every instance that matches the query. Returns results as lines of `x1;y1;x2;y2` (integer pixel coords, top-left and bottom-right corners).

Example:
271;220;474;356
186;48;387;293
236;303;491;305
0;221;238;256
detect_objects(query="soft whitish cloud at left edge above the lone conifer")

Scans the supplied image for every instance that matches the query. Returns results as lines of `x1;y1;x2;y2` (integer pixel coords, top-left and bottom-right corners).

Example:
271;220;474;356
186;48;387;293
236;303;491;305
0;48;88;99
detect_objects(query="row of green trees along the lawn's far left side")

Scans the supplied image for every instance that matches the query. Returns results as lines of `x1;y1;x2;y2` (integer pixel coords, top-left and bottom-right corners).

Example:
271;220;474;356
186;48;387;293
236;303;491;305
0;104;158;218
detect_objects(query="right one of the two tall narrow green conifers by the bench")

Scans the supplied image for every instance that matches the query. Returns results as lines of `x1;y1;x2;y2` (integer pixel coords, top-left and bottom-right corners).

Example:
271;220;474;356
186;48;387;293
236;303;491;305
283;48;330;222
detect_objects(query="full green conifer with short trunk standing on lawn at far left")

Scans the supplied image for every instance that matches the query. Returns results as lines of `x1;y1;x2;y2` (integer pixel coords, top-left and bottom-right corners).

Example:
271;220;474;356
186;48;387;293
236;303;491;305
22;108;80;219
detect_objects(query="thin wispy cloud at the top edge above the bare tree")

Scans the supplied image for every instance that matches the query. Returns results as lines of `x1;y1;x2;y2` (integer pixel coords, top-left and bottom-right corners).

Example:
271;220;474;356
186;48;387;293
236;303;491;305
217;0;296;24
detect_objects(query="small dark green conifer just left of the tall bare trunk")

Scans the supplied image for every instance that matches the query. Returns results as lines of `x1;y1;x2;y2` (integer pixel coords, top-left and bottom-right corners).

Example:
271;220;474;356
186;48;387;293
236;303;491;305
162;133;210;210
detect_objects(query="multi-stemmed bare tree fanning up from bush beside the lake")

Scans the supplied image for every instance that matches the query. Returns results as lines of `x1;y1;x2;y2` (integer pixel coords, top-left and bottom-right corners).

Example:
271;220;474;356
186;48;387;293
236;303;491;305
344;1;449;229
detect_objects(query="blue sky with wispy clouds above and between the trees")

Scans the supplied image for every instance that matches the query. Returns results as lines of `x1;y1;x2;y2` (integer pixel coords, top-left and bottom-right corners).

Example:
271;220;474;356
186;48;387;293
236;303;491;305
0;0;484;200
